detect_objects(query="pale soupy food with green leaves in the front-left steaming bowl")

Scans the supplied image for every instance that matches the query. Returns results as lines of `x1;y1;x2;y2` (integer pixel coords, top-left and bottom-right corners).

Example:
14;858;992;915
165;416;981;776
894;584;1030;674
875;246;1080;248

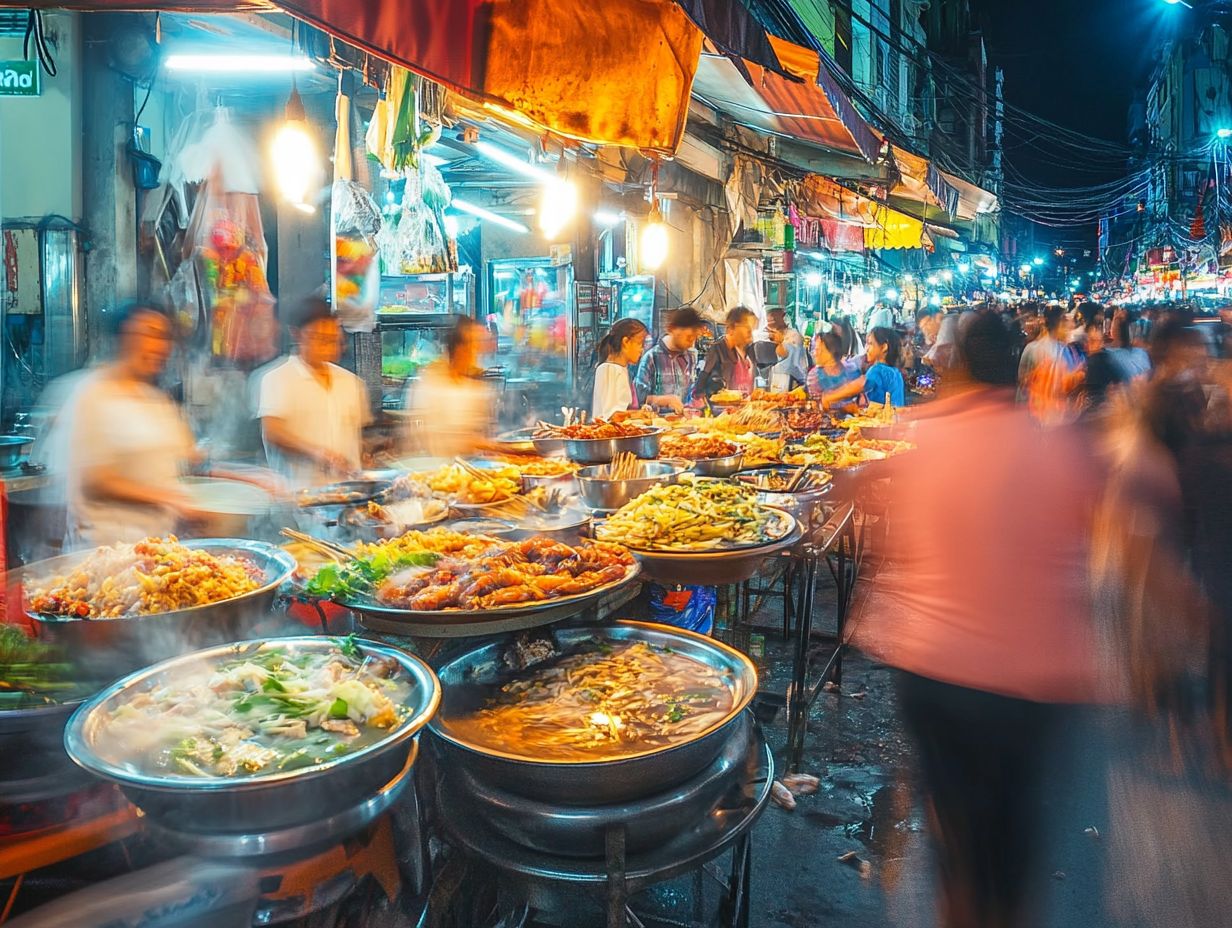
91;638;411;779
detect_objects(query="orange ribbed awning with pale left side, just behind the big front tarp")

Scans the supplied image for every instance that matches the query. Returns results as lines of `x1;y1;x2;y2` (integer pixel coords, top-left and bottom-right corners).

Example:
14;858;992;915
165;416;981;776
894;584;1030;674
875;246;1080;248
694;36;880;163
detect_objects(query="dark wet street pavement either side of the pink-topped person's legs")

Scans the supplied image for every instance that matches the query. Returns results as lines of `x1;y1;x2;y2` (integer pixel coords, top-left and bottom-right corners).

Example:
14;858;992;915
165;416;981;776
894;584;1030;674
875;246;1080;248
729;564;1232;928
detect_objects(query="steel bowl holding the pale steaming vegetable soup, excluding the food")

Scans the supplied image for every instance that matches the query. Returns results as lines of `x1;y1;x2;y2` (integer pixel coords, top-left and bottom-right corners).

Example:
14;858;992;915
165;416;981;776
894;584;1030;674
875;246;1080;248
64;637;441;834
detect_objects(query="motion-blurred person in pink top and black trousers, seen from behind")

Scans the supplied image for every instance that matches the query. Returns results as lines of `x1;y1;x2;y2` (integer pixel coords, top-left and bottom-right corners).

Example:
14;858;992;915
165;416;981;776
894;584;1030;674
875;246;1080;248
856;313;1098;928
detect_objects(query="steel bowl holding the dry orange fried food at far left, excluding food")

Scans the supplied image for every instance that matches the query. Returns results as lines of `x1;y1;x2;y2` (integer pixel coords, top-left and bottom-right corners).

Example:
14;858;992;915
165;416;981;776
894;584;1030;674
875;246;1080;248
21;539;296;679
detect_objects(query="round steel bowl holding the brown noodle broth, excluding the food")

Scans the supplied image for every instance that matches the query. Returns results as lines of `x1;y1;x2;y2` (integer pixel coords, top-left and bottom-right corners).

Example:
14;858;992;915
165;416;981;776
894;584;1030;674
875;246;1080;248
429;621;758;806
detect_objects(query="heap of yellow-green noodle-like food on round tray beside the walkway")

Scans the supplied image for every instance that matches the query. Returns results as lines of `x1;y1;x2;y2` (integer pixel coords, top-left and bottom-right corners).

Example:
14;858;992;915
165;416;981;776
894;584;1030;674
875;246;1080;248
595;481;790;551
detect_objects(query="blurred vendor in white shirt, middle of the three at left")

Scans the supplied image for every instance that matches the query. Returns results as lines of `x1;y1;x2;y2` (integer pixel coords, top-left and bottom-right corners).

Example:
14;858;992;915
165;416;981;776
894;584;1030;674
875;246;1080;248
257;297;372;488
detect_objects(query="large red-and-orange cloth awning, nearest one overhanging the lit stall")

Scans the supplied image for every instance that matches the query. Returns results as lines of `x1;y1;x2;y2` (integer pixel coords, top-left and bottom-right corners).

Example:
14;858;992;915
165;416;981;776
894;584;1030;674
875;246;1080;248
24;0;709;154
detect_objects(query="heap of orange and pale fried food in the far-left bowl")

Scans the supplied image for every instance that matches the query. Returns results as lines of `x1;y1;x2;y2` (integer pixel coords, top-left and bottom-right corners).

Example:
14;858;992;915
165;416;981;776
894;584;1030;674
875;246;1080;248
28;535;262;619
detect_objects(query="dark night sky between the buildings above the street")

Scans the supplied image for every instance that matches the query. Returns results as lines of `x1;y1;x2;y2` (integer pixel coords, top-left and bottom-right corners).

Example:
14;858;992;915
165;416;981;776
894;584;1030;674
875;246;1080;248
982;0;1172;247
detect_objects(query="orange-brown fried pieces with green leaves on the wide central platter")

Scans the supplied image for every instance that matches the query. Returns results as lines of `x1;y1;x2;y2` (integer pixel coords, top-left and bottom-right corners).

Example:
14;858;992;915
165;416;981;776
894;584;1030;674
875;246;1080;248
308;530;633;611
